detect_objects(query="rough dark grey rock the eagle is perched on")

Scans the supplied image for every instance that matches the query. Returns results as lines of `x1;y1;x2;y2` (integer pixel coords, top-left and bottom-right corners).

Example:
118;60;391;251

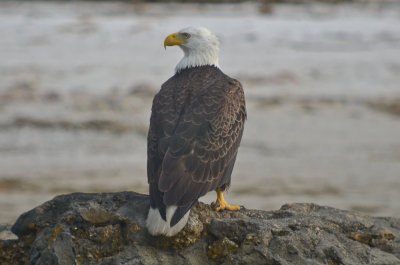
0;192;400;265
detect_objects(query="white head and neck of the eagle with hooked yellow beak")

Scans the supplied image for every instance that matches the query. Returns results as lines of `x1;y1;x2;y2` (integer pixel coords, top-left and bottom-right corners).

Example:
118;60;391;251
164;27;219;72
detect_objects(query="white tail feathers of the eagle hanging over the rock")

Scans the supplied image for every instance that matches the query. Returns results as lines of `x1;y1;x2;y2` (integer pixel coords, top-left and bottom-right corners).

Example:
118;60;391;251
146;205;190;236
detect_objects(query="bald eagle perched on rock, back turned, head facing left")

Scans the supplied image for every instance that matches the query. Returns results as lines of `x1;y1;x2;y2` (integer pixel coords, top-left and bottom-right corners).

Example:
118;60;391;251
146;27;246;236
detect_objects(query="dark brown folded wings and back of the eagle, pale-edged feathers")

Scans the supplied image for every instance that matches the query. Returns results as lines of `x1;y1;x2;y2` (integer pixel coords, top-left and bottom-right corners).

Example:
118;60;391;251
148;65;246;221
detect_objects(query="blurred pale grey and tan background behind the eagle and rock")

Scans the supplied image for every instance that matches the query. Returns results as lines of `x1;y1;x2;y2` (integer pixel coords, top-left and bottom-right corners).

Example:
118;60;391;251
0;0;400;223
